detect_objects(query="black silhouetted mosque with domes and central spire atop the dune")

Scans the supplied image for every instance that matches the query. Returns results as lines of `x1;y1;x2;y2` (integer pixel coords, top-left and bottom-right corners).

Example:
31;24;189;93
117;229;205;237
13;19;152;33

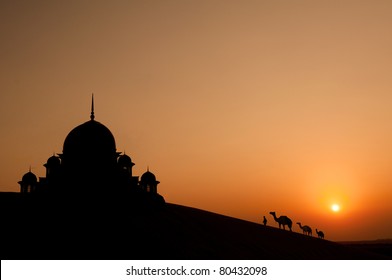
18;96;165;206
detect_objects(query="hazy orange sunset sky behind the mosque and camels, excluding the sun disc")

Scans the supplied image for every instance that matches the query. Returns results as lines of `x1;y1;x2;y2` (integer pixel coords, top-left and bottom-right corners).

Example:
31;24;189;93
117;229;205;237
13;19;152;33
0;0;392;240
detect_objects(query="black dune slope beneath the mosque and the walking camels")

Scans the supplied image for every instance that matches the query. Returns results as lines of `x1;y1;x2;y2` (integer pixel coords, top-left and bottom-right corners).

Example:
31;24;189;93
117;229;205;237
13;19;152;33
1;196;386;259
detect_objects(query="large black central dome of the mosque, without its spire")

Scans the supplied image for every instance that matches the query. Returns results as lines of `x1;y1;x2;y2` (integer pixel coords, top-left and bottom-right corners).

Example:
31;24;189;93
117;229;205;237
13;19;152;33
63;120;116;155
